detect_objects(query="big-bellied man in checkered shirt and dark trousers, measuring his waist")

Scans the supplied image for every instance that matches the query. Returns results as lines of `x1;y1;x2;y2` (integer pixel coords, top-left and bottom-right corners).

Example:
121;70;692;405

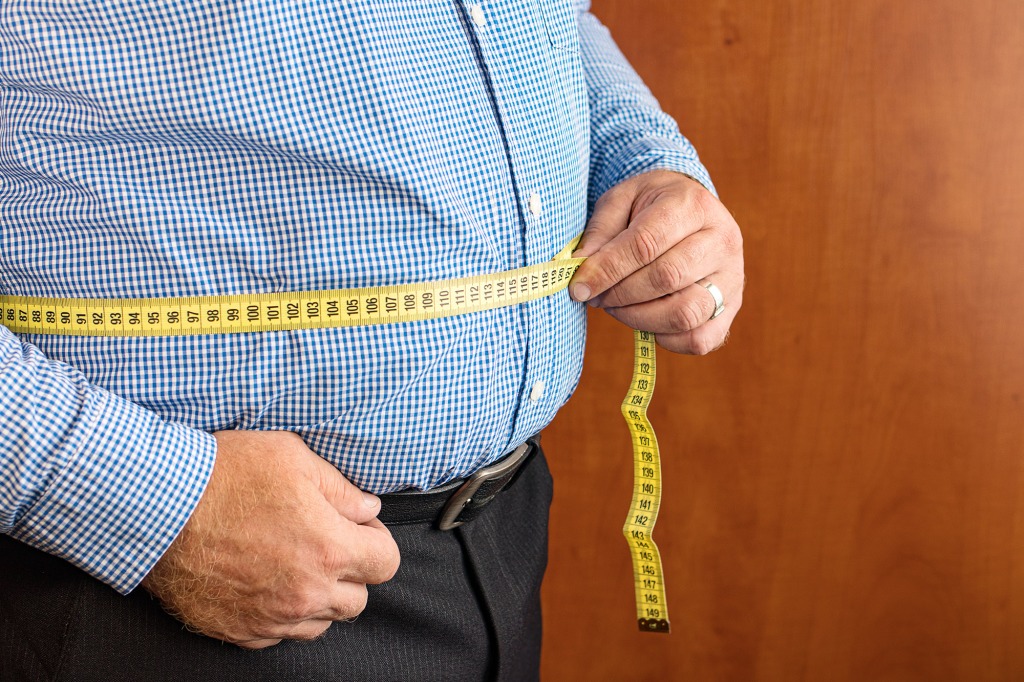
0;0;743;680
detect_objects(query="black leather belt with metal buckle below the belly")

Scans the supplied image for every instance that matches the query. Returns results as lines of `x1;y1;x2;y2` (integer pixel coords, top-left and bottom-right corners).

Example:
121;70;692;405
377;435;541;530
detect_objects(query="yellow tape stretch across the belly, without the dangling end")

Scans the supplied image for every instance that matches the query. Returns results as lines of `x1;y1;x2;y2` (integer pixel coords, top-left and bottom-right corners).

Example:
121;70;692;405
0;258;584;337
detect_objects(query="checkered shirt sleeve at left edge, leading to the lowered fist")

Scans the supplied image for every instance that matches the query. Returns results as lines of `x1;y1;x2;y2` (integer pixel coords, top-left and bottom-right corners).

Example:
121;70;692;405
0;327;216;594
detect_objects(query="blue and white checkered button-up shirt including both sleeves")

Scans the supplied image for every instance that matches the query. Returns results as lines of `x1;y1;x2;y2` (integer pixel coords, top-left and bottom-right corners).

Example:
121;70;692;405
0;0;710;592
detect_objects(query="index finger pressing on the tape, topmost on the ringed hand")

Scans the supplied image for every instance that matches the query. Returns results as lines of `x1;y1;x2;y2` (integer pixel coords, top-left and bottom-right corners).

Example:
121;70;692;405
569;196;703;301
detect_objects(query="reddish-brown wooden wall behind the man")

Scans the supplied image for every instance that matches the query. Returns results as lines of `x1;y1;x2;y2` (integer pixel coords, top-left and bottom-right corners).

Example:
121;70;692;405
543;0;1024;682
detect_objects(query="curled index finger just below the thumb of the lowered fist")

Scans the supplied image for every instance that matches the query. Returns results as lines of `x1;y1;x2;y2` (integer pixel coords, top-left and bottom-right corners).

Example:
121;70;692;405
325;519;400;585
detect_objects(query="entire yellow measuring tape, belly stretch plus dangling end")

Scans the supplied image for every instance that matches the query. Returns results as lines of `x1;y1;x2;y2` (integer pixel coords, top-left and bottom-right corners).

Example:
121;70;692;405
0;240;669;632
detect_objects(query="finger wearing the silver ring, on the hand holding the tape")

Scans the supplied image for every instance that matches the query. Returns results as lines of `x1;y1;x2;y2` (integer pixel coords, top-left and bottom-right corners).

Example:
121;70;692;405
607;272;742;339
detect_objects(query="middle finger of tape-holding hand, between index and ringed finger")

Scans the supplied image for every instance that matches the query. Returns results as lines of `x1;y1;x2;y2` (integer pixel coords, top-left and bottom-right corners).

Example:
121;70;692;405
590;229;726;308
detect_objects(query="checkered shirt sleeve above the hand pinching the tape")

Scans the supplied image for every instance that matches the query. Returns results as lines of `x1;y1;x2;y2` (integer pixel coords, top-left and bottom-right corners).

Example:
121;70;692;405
577;0;717;207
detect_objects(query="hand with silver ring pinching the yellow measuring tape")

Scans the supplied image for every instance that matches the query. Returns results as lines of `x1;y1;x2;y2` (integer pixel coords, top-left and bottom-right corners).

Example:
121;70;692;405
569;170;743;355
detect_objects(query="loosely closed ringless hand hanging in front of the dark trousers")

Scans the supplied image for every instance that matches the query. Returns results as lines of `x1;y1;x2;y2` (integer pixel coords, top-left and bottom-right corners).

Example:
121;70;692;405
142;431;398;649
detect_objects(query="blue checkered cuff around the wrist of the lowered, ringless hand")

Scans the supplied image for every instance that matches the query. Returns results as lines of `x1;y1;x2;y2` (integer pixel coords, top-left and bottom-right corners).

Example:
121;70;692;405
10;391;216;594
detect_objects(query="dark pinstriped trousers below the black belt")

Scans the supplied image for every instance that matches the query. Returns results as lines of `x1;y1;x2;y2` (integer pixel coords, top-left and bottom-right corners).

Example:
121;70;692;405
0;453;552;682
